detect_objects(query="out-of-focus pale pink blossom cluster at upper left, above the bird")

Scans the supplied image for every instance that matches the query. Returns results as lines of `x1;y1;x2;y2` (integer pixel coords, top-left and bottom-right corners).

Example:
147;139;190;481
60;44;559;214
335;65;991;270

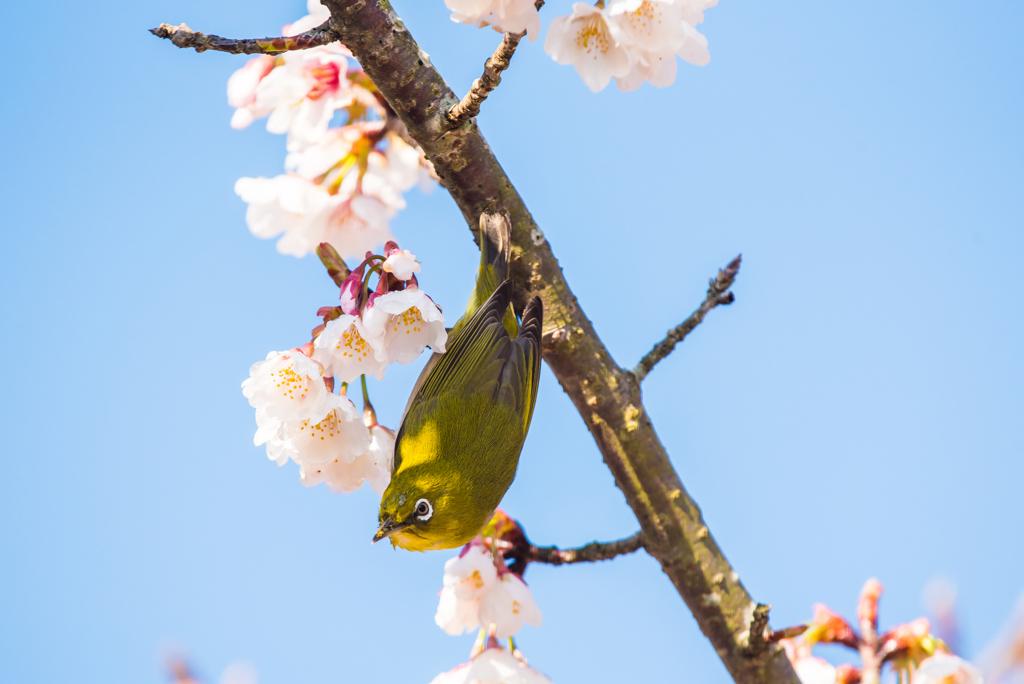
227;0;430;257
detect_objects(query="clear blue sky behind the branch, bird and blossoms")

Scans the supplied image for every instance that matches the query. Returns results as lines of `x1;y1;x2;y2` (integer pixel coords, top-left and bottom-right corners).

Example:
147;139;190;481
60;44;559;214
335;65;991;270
0;0;1024;684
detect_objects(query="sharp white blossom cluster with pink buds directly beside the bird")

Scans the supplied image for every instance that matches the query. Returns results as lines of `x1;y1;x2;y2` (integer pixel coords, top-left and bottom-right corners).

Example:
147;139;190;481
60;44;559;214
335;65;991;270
242;242;447;494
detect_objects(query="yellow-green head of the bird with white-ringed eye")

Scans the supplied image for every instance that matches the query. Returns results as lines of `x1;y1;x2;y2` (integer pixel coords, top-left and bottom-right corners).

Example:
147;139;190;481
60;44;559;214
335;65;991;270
374;468;492;551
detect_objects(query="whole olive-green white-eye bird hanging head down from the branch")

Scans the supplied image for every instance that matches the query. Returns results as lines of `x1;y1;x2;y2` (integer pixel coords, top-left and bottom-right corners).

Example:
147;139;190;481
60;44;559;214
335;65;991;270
374;217;544;551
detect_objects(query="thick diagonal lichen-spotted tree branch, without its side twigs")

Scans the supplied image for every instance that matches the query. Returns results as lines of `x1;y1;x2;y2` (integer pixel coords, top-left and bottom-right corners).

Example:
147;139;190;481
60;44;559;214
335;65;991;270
324;0;799;684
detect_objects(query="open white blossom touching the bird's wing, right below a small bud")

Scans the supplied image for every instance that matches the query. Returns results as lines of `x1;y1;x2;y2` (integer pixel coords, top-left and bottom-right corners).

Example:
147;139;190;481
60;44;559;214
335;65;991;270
364;288;447;364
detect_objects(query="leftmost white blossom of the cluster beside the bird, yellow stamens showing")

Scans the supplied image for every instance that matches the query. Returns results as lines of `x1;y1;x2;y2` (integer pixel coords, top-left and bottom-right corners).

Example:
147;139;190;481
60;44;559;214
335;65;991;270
242;349;331;423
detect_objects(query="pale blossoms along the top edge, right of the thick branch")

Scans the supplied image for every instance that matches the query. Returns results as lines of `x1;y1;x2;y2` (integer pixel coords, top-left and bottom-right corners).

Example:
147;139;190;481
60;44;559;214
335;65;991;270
445;0;718;92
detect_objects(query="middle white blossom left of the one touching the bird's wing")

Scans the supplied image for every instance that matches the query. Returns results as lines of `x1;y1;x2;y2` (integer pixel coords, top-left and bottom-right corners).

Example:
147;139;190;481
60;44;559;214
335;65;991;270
313;313;387;382
